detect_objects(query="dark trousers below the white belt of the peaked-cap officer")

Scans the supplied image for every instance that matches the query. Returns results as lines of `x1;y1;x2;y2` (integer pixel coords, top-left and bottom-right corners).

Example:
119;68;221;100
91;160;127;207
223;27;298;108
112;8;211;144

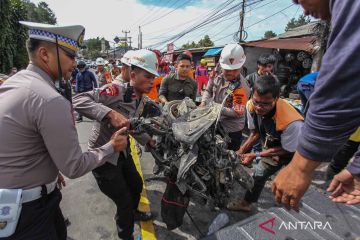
0;188;67;240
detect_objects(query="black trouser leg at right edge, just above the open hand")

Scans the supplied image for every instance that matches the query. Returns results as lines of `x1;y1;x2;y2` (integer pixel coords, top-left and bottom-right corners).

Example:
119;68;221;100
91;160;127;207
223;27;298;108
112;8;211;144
326;140;360;180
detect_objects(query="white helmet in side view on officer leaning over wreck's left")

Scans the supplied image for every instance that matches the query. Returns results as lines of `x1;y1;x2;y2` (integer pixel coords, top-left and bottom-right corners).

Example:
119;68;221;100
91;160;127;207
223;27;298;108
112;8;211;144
130;49;159;77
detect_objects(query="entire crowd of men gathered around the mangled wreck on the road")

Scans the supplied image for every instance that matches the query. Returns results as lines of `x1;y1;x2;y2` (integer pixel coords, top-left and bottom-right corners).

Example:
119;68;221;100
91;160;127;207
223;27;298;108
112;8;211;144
0;0;360;240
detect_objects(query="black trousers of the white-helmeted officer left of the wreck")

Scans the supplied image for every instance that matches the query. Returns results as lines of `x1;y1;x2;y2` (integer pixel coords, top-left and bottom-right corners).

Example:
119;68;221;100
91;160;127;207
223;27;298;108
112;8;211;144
93;151;143;239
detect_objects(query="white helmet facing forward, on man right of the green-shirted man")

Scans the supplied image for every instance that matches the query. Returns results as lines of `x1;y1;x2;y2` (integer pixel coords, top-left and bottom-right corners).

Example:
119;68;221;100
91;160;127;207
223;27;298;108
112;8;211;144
219;43;246;70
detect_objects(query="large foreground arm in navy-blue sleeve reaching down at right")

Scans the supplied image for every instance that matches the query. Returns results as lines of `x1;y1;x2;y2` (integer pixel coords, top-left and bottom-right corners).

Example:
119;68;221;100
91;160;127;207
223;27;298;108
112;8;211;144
273;1;360;210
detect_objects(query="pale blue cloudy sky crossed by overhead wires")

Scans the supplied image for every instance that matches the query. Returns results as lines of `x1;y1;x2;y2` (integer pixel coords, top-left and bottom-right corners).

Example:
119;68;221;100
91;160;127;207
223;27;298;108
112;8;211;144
30;0;302;50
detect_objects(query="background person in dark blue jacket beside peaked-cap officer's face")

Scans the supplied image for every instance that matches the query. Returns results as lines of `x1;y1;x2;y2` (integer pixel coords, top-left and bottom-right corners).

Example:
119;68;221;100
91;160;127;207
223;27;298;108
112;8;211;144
75;61;98;122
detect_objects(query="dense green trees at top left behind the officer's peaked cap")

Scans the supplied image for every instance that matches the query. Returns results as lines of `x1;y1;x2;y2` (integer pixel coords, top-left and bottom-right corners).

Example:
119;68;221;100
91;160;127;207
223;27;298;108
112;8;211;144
0;0;56;74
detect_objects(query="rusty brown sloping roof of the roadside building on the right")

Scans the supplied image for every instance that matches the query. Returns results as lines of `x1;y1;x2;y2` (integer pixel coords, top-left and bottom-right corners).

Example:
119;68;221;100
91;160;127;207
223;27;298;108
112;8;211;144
242;36;316;53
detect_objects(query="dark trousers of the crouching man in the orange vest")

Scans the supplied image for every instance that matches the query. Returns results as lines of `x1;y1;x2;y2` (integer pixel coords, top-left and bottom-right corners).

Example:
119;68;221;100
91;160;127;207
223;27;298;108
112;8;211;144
244;155;292;203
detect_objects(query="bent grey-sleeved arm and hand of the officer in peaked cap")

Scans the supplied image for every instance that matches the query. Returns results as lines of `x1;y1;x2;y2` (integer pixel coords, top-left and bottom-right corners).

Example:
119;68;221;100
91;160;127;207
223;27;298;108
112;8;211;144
36;96;127;178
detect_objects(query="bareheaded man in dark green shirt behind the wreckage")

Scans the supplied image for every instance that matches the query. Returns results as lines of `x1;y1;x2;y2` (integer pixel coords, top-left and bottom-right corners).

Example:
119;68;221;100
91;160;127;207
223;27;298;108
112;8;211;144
159;54;197;104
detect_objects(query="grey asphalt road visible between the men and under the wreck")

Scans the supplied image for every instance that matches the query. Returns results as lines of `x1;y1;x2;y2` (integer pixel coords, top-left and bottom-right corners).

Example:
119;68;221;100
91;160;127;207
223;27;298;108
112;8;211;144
61;119;332;240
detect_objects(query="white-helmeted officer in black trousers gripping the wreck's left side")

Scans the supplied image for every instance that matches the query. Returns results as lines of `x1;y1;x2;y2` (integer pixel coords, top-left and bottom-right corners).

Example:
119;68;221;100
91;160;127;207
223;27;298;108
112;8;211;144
73;49;158;239
